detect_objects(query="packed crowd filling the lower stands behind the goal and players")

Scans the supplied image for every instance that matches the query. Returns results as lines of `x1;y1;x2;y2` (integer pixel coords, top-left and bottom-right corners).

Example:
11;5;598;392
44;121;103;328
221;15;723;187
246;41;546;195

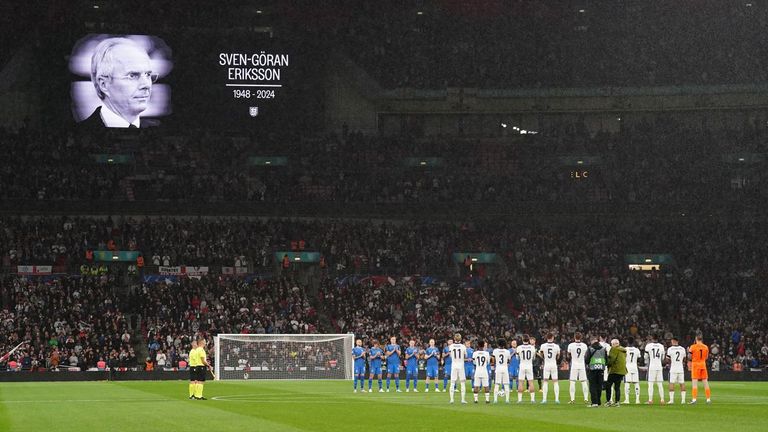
0;217;768;369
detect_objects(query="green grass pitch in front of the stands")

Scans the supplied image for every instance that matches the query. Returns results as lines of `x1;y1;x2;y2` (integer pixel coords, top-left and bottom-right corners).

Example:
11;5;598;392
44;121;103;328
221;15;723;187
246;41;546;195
0;381;768;432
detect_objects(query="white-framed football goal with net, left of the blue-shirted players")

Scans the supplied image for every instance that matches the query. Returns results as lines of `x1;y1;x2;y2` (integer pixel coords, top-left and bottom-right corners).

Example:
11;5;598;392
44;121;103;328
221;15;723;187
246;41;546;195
214;333;355;381
